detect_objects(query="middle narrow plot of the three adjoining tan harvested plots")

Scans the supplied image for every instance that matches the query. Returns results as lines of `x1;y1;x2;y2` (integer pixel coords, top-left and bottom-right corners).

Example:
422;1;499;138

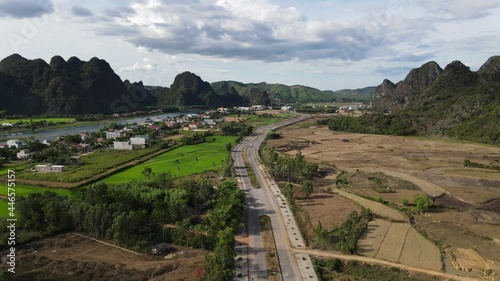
375;223;411;262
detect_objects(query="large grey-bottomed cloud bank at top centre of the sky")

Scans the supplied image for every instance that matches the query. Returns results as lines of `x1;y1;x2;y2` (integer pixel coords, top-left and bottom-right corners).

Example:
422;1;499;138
94;0;418;62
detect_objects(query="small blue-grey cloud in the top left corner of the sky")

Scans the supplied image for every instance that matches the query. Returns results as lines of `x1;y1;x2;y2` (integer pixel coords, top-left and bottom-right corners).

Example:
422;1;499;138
0;0;55;18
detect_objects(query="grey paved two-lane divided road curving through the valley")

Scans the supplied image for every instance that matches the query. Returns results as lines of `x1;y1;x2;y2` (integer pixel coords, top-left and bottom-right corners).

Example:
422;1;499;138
233;116;317;280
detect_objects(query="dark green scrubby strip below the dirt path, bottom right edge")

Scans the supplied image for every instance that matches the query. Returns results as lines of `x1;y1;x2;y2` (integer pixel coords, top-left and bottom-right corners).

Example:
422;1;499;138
313;258;443;281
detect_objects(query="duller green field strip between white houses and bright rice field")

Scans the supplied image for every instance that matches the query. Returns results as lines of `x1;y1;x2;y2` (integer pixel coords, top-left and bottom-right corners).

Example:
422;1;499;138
18;148;158;182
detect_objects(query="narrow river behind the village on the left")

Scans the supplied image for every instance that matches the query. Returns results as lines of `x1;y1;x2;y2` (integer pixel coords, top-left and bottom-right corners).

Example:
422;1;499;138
0;112;187;141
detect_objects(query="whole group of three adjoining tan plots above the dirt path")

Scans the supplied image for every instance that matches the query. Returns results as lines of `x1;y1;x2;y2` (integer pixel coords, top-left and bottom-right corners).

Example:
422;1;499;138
358;219;442;271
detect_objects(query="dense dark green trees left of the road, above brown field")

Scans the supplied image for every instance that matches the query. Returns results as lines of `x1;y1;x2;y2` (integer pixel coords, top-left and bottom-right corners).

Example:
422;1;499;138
0;176;244;280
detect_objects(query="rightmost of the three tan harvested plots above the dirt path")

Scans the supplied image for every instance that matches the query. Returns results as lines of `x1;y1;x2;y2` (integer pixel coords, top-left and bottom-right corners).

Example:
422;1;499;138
399;227;442;271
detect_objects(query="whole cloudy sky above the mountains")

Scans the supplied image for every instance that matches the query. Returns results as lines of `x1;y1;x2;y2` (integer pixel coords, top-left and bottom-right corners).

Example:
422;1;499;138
0;0;500;90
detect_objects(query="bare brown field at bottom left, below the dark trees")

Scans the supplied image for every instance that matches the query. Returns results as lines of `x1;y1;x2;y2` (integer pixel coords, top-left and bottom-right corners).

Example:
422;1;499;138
2;234;206;281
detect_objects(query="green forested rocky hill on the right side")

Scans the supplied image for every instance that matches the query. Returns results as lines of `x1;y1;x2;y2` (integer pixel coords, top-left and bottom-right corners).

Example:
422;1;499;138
330;56;500;145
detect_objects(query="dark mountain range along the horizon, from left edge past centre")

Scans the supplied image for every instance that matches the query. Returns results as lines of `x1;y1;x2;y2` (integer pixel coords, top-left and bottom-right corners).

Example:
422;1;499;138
0;54;375;115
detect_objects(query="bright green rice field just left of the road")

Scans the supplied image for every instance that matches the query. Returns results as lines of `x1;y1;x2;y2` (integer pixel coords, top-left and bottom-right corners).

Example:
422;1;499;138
103;136;236;184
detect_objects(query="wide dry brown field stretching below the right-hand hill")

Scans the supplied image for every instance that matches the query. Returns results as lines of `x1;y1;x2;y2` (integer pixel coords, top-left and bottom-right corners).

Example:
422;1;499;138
268;120;500;203
